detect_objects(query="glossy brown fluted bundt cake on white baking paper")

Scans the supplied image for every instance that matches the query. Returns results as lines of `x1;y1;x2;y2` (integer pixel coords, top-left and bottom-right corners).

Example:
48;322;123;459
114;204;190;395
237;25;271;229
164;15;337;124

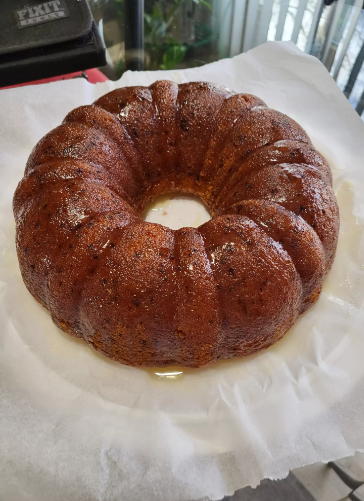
14;81;339;367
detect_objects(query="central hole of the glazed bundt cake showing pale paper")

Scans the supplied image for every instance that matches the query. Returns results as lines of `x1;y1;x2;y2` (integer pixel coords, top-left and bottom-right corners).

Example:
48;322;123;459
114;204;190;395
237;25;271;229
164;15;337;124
142;193;211;230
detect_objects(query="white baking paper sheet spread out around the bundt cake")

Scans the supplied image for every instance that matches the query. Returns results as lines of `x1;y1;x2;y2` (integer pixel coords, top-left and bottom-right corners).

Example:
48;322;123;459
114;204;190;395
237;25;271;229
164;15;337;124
0;42;364;501
